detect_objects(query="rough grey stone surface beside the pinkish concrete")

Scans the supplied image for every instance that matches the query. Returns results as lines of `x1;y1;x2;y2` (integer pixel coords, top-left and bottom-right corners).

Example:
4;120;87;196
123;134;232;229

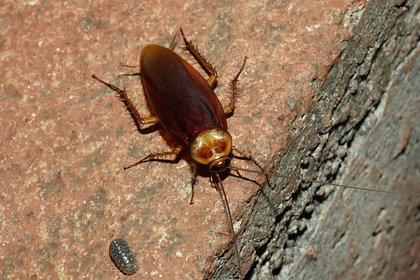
231;1;420;279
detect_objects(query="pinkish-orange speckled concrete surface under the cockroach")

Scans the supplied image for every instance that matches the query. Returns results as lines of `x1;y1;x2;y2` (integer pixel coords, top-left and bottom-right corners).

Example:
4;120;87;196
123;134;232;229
0;0;363;279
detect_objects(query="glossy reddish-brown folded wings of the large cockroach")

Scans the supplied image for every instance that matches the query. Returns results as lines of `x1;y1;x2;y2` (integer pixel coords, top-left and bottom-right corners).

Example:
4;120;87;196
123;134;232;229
140;45;227;145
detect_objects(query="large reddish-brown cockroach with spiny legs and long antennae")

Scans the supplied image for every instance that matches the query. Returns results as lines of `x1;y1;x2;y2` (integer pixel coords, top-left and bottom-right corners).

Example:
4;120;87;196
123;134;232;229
92;28;268;278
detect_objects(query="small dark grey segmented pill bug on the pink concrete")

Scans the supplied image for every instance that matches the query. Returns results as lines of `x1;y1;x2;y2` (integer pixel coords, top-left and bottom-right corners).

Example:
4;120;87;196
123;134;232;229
109;239;138;275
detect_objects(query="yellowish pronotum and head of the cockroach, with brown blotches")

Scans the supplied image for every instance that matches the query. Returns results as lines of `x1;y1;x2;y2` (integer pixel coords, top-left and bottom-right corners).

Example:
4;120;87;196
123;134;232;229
190;128;232;172
